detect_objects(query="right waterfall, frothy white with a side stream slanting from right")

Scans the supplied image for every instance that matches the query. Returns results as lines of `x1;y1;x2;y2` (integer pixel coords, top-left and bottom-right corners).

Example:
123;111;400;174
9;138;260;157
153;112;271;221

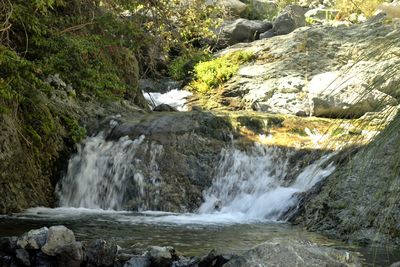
199;145;335;220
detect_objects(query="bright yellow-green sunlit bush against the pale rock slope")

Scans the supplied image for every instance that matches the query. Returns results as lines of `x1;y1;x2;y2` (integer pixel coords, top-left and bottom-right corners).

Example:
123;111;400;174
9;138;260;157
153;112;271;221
191;51;254;93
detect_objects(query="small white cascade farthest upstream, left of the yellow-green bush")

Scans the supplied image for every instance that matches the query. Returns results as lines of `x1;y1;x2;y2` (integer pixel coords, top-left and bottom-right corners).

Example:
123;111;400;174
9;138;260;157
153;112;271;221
143;89;192;111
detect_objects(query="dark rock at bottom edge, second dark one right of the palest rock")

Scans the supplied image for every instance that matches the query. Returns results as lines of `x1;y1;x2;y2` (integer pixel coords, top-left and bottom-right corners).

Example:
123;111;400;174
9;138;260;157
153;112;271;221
84;239;118;266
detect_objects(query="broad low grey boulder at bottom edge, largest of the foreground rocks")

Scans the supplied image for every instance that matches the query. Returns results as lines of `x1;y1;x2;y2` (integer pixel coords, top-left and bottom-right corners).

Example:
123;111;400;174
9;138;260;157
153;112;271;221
224;238;361;267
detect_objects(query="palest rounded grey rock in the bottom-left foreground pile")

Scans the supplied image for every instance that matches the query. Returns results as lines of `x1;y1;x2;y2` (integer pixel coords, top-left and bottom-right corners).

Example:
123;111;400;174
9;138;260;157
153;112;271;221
42;225;75;256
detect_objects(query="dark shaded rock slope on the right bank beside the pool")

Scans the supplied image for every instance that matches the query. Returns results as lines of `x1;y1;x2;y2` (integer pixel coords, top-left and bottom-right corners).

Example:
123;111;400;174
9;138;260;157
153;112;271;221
292;113;400;243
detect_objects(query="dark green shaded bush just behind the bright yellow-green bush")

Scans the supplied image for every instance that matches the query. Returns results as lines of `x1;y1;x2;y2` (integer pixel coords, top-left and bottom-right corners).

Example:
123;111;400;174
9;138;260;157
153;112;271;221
168;50;211;81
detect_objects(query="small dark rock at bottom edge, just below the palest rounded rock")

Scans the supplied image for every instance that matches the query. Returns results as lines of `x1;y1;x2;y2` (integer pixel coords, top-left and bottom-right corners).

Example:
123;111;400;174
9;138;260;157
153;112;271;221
54;242;84;267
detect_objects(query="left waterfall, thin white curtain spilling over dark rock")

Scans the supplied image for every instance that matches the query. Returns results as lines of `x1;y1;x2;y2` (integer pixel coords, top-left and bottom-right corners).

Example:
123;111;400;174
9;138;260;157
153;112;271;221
56;133;163;210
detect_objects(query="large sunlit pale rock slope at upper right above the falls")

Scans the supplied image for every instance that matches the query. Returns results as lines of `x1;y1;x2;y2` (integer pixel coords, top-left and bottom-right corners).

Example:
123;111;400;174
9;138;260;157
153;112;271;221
202;19;400;118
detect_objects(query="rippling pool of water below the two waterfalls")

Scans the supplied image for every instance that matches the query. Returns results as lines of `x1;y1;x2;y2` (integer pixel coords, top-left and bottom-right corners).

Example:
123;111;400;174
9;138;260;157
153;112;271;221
0;208;400;266
